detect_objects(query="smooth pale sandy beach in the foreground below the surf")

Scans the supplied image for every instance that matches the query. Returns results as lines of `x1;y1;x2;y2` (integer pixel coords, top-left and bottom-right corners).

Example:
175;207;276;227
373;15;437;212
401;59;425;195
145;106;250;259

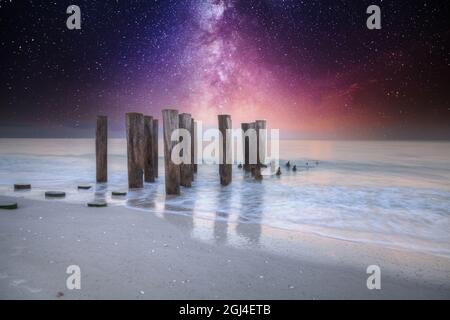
0;197;450;299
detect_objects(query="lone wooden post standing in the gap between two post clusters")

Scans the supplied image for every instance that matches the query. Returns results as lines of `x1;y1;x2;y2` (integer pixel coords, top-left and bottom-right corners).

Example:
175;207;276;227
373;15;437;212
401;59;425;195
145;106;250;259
218;115;232;186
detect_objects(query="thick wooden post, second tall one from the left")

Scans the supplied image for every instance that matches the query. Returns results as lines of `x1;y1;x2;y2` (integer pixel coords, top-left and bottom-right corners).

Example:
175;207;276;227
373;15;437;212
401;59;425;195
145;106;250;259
126;113;144;189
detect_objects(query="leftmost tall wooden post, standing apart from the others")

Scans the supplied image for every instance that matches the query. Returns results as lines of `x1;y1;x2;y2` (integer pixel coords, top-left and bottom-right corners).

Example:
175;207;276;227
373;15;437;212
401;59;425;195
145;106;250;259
95;116;108;183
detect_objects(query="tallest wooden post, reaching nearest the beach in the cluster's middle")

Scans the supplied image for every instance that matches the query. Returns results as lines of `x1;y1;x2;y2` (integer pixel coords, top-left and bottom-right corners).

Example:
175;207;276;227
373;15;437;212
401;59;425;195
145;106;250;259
162;110;180;195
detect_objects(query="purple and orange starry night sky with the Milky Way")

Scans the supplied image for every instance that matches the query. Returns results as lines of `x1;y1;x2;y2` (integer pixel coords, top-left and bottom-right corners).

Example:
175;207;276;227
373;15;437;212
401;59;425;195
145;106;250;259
0;0;450;139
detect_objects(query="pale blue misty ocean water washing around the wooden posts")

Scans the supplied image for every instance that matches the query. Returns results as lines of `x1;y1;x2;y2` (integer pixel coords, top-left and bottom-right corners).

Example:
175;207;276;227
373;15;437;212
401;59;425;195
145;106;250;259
0;139;450;256
